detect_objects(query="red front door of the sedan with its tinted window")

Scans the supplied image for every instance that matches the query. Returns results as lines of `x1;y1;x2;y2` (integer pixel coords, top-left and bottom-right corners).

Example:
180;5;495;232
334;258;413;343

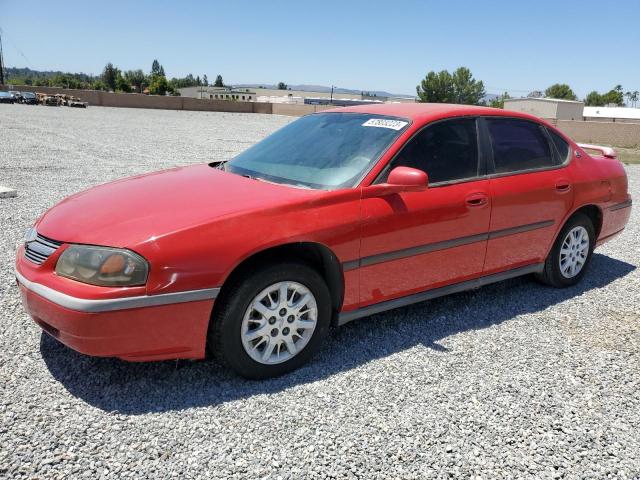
360;117;491;307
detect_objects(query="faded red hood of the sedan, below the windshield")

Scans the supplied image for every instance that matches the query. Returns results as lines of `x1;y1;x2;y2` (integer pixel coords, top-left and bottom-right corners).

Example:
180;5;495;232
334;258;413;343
37;165;324;248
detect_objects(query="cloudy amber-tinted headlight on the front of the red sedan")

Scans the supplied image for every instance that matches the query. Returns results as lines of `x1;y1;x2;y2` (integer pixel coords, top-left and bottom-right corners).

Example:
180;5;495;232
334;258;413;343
56;245;149;287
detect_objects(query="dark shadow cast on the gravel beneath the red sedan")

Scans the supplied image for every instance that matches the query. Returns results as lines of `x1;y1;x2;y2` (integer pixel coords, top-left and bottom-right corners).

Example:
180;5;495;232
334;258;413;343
40;254;636;415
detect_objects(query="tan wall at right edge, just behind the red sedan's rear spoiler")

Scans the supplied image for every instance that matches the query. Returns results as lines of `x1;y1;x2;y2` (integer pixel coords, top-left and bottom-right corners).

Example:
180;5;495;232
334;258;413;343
553;120;640;148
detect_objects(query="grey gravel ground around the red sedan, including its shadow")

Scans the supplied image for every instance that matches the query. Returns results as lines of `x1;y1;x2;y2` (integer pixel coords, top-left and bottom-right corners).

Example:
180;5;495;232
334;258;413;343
0;105;640;479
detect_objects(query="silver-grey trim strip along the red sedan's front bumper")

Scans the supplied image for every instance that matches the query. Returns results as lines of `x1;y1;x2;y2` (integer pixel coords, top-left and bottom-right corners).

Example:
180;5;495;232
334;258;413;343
15;270;220;313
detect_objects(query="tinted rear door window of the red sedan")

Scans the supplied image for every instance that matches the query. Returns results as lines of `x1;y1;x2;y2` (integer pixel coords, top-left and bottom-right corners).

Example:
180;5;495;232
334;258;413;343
487;118;557;173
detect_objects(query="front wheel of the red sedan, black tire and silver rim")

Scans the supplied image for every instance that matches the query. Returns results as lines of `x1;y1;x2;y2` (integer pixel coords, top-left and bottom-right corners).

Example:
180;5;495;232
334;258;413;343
208;263;331;379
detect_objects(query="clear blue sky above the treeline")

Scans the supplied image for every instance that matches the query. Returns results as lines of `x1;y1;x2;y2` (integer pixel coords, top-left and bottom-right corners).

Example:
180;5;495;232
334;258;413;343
0;0;640;98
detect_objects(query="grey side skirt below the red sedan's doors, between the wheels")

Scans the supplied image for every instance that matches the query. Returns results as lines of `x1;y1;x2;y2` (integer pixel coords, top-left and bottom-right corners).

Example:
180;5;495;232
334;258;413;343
338;263;544;325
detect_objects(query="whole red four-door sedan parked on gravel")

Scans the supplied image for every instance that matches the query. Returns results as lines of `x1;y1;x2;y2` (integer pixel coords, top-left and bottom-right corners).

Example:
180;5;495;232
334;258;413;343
16;104;631;378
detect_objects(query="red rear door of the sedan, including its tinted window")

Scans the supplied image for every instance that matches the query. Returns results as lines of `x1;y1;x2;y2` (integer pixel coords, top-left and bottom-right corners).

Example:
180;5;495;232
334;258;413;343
481;117;573;274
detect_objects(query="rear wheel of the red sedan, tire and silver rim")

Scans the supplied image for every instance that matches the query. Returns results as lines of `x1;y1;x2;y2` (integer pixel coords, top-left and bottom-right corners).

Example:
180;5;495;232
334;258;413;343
536;213;596;288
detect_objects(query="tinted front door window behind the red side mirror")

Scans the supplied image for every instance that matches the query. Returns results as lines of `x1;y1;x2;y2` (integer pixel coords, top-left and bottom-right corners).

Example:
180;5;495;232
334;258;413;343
382;118;478;183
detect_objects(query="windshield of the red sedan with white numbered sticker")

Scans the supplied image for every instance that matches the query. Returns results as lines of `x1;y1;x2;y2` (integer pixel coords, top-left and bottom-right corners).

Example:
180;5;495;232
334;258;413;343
224;113;409;190
